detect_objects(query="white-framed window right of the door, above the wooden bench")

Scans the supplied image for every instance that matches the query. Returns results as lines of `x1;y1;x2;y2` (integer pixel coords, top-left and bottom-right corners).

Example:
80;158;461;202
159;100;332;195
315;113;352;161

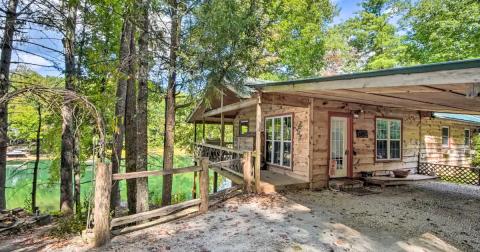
376;118;402;160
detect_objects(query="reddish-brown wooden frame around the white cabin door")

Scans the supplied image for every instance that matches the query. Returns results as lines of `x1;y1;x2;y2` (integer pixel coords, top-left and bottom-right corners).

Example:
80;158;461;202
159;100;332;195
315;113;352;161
327;111;353;179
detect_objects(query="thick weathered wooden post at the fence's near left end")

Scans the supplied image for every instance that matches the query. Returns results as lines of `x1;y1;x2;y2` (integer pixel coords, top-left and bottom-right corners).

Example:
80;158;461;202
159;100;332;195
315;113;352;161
93;161;112;247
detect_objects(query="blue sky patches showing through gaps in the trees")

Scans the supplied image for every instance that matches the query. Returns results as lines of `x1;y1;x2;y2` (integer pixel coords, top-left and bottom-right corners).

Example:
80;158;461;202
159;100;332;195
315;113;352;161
12;0;361;76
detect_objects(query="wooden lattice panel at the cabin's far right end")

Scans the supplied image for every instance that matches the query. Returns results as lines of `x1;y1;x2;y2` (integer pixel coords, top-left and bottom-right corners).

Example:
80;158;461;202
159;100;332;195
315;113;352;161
418;162;480;185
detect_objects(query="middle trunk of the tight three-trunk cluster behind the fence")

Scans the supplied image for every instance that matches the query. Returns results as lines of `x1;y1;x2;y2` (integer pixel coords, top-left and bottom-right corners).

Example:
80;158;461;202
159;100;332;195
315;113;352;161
125;25;137;214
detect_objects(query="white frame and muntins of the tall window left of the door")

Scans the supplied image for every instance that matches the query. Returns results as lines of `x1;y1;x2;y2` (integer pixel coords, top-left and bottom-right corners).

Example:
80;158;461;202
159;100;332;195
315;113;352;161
264;115;293;169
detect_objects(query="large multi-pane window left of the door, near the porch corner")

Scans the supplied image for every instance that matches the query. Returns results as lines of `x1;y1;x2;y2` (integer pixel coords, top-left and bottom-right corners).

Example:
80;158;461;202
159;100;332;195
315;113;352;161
265;115;292;168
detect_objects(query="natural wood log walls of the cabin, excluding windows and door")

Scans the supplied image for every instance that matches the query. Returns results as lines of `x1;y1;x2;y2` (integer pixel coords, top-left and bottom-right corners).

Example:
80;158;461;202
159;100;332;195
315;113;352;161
234;94;478;188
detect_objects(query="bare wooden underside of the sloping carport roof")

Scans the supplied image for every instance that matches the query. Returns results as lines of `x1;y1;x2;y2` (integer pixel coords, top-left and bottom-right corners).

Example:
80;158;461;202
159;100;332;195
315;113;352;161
251;60;480;114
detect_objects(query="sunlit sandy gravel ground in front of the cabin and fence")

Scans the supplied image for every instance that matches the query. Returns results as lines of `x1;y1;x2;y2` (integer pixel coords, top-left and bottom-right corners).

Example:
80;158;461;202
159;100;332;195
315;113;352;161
0;182;480;251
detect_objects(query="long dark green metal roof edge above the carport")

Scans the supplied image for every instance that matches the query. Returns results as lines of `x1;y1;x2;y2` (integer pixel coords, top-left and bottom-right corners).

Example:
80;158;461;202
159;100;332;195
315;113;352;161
247;59;480;88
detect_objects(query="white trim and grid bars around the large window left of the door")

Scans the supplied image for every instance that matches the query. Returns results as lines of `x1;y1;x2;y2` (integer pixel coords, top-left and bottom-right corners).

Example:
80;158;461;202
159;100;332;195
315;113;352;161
263;113;294;170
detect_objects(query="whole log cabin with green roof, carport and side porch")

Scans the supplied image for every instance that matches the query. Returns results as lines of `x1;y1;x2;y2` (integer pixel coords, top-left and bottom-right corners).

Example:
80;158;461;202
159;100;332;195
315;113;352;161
188;59;480;191
